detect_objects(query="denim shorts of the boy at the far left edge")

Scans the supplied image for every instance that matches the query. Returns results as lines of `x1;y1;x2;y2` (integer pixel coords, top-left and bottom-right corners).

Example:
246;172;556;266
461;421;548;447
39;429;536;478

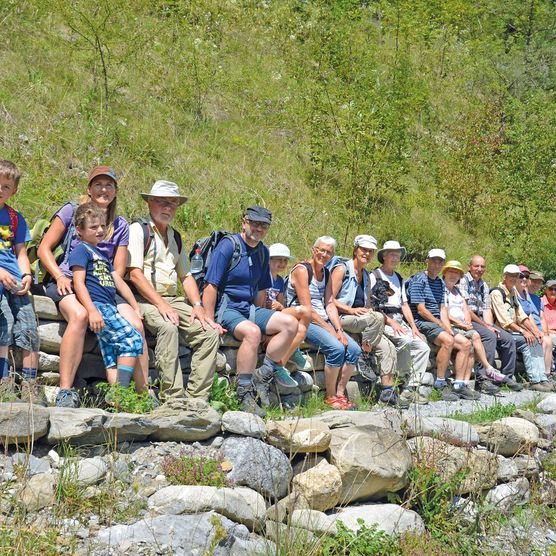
0;291;39;351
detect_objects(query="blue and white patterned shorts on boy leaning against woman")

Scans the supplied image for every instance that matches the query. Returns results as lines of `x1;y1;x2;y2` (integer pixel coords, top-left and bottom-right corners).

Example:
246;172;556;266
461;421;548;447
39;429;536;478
94;301;143;369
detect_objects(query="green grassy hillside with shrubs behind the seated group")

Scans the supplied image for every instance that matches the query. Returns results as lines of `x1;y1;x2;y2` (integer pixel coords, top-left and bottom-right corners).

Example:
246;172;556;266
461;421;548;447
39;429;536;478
0;0;556;277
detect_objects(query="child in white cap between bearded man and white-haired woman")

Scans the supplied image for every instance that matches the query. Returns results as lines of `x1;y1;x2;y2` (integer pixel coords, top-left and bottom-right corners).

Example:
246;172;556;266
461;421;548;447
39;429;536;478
266;243;312;371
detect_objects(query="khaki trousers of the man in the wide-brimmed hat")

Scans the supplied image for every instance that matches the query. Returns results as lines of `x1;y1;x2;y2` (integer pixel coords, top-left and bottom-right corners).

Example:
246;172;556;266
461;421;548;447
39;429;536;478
138;297;220;401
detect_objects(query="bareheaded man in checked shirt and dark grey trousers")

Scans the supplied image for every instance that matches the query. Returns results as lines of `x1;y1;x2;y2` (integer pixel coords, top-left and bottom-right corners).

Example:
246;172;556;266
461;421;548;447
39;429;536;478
458;255;523;394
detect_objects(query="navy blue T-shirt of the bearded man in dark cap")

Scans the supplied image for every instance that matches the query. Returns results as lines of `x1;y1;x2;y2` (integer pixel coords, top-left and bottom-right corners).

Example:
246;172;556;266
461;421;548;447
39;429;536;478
205;234;272;318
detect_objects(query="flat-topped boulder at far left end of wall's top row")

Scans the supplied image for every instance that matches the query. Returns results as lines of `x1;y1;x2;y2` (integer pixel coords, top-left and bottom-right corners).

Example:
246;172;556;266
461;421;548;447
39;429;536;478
0;403;48;445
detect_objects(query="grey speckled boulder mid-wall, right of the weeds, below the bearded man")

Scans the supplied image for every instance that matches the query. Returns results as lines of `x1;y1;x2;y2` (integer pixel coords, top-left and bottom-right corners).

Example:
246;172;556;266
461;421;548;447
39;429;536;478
222;436;292;499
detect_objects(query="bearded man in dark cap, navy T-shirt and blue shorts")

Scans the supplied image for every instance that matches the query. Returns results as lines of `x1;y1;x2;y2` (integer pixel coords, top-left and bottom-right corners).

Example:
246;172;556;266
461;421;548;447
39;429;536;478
203;206;297;415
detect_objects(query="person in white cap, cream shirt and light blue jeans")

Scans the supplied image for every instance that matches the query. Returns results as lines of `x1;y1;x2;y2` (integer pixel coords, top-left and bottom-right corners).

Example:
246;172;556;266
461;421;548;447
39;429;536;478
490;264;552;392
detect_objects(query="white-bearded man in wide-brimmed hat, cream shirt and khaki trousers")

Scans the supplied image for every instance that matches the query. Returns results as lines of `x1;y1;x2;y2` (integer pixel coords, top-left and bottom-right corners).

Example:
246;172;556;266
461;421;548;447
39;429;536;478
128;180;222;401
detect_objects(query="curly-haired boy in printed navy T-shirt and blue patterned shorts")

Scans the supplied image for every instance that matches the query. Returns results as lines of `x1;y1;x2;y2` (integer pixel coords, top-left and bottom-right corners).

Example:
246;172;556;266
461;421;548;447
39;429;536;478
69;203;143;388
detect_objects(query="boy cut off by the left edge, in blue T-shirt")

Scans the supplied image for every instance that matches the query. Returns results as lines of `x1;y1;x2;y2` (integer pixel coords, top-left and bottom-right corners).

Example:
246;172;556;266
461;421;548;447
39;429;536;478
0;160;46;405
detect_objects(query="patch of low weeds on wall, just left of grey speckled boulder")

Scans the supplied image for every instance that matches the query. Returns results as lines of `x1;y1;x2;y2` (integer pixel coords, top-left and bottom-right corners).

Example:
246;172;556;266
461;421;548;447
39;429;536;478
162;453;231;488
